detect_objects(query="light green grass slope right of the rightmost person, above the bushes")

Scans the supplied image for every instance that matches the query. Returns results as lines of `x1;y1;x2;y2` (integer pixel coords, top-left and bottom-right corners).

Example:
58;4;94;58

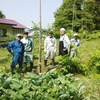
78;39;100;63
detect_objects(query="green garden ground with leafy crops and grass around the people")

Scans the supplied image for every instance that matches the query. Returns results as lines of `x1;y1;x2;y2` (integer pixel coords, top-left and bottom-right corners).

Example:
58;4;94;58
0;32;100;100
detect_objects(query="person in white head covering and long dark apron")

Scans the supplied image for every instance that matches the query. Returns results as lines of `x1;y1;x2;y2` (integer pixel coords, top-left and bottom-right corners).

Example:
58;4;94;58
59;28;70;56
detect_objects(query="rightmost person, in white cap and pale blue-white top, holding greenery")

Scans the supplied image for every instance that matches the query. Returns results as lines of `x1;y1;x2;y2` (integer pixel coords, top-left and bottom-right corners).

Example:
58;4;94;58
70;33;80;58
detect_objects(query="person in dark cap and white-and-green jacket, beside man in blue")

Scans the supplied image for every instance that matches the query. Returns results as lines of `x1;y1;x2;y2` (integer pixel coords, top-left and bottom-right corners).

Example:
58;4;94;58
21;32;33;71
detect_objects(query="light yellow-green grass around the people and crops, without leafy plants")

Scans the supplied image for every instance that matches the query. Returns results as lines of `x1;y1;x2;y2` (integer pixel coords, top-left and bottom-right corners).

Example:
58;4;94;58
0;39;100;100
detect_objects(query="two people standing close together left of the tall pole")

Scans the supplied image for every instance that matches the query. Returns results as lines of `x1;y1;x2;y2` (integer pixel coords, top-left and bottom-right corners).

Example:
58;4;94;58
7;32;34;73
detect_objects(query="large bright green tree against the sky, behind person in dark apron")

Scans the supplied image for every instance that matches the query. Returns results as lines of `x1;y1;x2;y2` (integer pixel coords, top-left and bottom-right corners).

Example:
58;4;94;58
54;0;83;31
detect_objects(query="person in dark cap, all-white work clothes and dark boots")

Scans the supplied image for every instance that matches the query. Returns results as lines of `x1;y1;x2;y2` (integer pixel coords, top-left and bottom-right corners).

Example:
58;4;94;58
44;31;56;67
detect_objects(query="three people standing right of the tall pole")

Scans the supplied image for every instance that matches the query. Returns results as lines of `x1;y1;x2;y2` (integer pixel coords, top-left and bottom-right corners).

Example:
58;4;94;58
44;28;80;67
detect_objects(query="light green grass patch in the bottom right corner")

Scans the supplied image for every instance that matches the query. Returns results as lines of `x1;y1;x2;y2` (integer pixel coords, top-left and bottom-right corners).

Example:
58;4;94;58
73;73;100;100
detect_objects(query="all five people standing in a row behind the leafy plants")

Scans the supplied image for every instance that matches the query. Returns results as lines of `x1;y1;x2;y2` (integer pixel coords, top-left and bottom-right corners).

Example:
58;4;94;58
7;28;80;73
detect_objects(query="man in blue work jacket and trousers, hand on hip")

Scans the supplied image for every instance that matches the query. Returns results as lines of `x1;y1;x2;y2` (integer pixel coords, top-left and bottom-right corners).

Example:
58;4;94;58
7;34;24;73
